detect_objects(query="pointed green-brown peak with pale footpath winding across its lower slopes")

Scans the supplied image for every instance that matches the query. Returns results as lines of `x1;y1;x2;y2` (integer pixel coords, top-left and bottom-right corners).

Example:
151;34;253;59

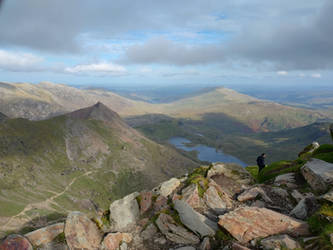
0;103;198;231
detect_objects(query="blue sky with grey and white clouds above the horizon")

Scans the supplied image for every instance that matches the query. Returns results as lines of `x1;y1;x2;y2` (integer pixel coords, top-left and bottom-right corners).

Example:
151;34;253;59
0;0;333;85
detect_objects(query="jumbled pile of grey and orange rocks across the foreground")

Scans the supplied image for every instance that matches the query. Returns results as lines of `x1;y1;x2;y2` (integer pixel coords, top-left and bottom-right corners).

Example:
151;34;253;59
0;159;333;250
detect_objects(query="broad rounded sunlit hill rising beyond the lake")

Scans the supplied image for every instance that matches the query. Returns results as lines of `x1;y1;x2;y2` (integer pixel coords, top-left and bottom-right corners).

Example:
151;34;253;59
159;88;328;131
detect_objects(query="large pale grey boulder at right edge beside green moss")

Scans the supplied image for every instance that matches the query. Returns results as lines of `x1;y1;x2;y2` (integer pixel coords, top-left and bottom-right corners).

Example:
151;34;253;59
301;159;333;193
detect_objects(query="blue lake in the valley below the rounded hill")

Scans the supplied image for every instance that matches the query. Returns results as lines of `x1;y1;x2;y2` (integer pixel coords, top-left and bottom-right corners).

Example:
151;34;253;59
168;137;248;167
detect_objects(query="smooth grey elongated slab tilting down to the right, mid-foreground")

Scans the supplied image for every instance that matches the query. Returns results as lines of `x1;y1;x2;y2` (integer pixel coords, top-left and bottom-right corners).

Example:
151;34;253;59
174;200;217;237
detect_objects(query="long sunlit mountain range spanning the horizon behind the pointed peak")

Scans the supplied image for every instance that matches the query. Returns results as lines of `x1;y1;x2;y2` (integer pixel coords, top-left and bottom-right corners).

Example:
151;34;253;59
0;82;332;132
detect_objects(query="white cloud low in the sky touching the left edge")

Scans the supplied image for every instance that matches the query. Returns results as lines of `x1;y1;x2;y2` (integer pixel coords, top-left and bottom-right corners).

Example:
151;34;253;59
0;50;44;72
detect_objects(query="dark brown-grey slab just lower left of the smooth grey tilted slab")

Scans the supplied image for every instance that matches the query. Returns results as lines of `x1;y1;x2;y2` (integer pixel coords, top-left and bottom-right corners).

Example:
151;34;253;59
156;213;200;245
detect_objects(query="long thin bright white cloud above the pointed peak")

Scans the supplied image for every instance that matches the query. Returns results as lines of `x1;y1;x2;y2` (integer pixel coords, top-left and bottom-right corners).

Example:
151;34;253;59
65;62;127;76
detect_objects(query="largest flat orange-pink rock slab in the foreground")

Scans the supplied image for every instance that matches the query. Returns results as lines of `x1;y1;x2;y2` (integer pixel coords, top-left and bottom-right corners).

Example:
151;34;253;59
219;207;309;243
